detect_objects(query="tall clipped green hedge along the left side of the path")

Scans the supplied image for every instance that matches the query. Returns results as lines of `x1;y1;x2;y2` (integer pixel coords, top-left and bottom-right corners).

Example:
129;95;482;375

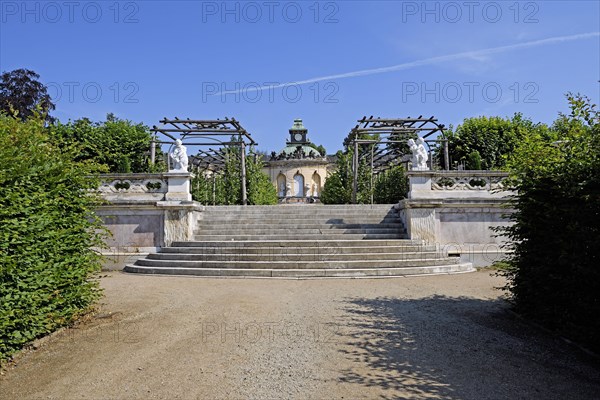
0;114;103;360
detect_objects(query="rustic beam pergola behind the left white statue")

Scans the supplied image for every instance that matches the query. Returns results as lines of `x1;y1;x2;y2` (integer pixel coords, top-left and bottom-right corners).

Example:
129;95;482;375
150;117;258;205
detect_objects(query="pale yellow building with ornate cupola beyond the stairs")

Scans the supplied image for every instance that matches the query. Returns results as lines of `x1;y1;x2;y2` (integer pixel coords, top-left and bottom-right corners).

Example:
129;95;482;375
264;119;334;203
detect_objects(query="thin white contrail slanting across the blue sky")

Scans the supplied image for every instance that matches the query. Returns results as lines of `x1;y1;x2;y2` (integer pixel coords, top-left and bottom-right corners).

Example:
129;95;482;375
212;32;600;96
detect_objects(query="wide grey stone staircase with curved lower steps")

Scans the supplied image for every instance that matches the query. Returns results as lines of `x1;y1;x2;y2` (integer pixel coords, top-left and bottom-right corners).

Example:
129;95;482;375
125;204;473;278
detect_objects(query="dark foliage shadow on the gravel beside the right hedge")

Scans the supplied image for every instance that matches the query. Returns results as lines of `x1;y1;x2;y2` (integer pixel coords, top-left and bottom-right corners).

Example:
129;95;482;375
338;296;600;400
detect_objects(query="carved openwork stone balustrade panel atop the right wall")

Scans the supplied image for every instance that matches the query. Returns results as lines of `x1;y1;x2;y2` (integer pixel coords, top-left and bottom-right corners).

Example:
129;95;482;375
430;171;508;191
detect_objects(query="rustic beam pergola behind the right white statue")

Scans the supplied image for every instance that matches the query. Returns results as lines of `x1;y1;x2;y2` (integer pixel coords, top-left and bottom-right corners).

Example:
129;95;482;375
346;115;450;204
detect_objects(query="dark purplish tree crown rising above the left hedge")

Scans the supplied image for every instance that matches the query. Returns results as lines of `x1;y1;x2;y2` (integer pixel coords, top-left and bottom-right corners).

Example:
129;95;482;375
0;69;56;122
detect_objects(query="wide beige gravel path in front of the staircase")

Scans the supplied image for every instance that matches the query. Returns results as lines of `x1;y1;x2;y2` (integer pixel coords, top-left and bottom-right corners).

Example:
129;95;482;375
0;272;600;400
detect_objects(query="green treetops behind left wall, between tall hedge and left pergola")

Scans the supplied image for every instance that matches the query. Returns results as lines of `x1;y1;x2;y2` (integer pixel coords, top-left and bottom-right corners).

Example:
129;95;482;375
51;114;158;172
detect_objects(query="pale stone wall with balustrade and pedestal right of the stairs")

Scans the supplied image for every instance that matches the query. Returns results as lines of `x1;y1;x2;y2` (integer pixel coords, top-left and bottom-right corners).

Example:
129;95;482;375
397;171;512;266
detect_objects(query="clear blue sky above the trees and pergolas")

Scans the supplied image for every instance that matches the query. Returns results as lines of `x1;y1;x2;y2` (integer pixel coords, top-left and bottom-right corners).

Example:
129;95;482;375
0;0;600;153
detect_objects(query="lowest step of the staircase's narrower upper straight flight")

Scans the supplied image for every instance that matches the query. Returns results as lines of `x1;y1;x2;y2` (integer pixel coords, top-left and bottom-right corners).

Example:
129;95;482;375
194;233;406;241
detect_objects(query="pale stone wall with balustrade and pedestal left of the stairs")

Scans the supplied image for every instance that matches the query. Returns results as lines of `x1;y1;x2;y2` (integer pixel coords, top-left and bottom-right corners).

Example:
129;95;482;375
96;172;203;269
